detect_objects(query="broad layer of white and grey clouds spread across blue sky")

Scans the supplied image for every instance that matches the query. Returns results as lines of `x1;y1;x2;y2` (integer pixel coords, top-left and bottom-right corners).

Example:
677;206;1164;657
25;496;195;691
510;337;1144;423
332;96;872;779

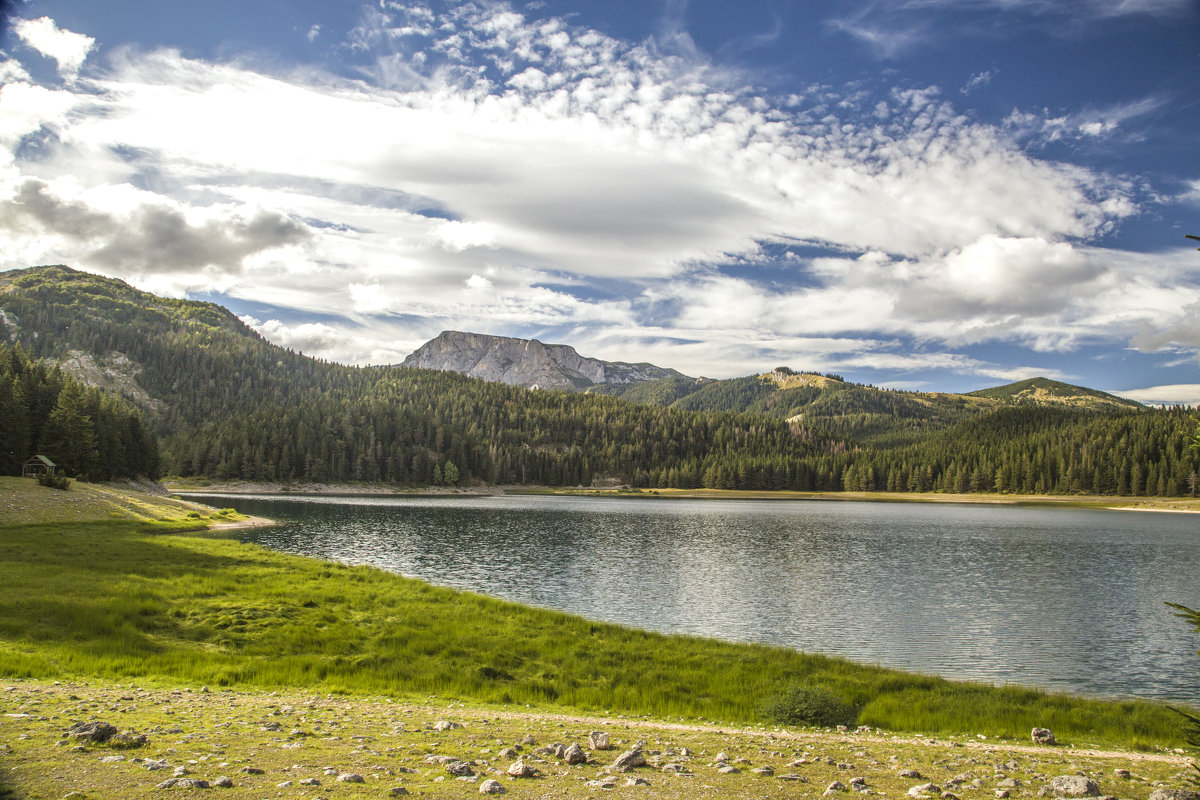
0;0;1200;398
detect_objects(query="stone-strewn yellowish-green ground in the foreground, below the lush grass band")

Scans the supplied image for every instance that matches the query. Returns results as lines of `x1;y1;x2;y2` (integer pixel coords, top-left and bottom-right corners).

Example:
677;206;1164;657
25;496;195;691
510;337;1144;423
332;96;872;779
0;680;1200;800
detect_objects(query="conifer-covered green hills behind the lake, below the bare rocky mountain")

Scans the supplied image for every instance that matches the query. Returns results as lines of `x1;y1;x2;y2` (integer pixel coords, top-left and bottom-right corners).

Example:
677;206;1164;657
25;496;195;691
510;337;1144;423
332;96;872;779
0;267;1200;495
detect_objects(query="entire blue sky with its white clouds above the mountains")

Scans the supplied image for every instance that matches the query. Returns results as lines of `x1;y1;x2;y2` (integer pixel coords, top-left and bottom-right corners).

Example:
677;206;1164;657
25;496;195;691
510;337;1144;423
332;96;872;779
0;0;1200;404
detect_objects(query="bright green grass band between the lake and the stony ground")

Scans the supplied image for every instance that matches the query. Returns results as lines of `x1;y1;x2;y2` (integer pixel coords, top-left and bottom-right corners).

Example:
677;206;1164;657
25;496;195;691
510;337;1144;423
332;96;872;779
0;506;1180;747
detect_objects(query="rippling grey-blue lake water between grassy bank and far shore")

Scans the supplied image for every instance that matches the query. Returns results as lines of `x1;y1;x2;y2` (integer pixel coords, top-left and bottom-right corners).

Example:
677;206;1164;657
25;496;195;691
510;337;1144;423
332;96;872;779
196;495;1200;704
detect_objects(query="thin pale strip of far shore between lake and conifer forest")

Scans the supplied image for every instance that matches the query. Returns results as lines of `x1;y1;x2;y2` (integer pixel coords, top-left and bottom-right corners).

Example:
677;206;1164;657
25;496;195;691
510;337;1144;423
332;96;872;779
163;480;1200;513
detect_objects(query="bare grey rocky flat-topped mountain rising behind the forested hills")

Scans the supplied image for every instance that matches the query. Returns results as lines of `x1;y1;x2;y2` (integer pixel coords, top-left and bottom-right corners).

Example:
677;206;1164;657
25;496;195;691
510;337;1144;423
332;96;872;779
401;331;694;391
